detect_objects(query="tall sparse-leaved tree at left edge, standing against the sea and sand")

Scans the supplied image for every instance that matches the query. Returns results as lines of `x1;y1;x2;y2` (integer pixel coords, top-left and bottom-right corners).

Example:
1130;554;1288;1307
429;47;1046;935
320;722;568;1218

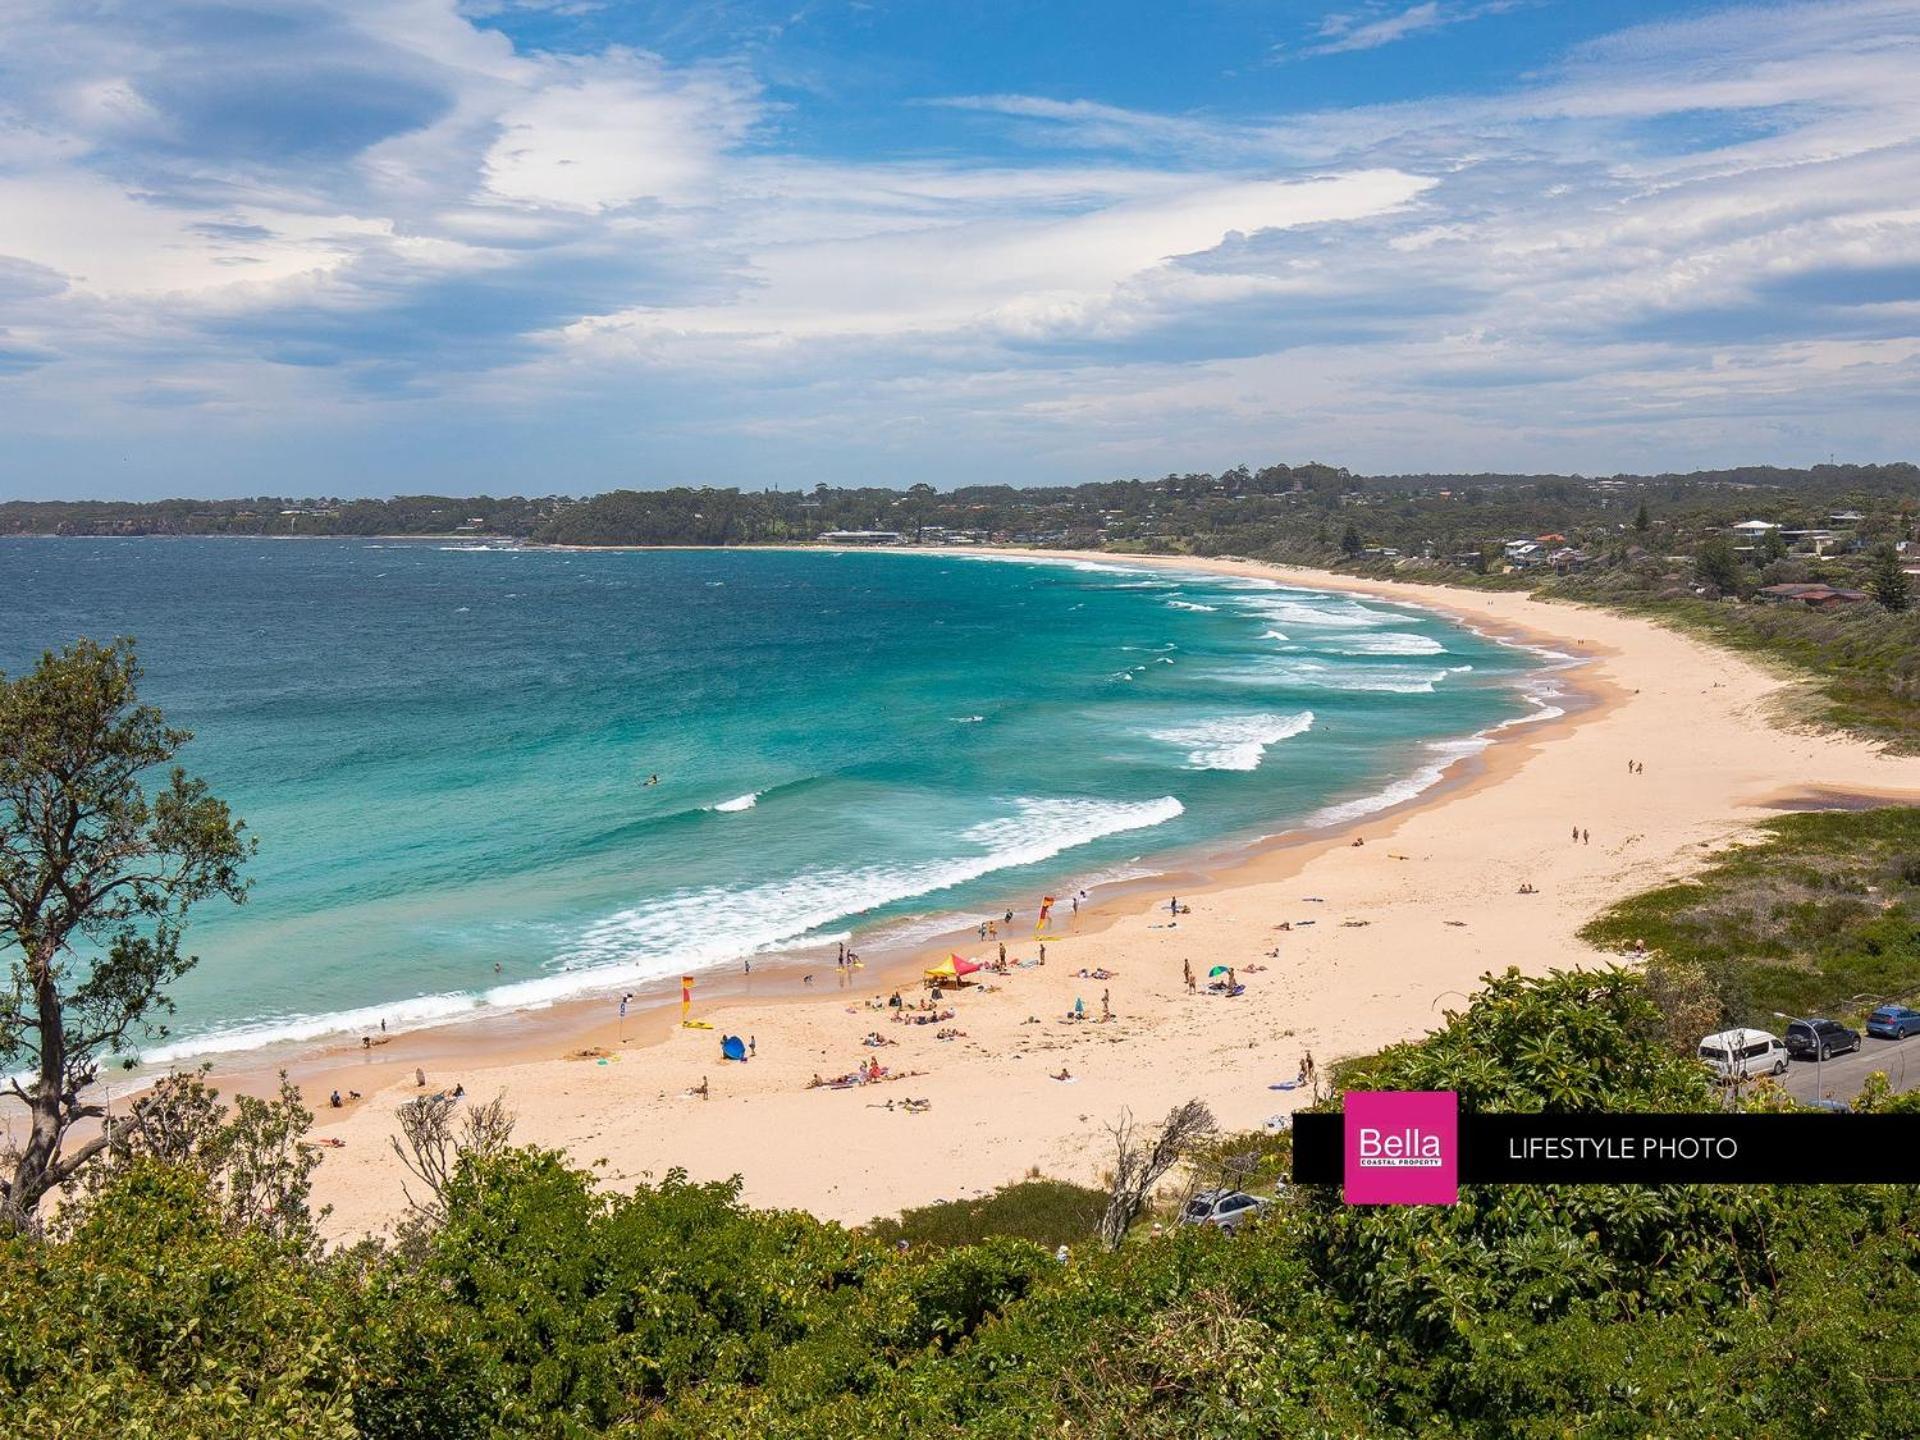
0;639;253;1229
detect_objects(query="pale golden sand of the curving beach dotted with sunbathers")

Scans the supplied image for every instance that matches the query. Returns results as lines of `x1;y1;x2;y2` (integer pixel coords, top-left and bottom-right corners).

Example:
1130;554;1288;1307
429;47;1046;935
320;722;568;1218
206;555;1920;1240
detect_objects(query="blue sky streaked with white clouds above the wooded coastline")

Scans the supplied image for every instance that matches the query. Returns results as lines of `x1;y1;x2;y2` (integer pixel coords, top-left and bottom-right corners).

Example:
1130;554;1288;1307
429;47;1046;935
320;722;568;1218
0;0;1920;499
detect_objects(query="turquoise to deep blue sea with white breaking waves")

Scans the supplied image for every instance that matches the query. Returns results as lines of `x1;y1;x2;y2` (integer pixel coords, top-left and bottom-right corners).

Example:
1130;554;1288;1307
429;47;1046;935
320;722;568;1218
0;540;1548;1060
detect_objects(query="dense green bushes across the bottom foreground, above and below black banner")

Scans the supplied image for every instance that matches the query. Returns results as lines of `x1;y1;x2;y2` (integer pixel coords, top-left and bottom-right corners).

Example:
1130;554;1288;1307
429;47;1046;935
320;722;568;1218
11;972;1920;1440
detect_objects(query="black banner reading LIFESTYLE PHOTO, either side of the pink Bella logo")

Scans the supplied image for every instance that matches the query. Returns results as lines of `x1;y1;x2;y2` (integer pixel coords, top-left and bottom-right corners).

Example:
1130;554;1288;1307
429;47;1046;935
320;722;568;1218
1292;1114;1920;1185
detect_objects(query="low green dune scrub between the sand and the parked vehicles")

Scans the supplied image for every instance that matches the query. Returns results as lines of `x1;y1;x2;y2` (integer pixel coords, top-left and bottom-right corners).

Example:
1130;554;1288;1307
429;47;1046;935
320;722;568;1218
1582;806;1920;1033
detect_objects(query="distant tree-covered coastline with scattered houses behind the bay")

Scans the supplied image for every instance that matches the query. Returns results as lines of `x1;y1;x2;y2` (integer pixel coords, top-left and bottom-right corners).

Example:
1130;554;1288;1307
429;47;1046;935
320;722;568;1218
0;463;1920;751
